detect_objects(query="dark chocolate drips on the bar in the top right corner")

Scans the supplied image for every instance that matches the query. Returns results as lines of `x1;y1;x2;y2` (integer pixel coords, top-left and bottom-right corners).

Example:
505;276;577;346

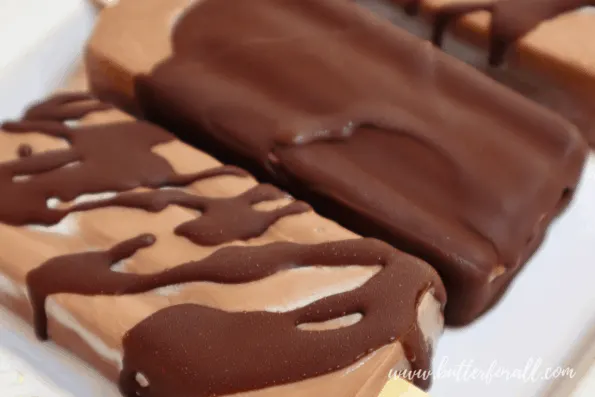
432;0;595;66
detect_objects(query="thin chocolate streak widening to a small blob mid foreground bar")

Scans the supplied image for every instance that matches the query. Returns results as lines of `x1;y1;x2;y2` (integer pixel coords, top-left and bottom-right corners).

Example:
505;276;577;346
66;185;310;245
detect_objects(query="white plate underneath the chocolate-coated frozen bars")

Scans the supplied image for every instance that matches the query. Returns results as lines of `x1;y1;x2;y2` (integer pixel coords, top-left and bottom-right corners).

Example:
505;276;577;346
0;0;595;397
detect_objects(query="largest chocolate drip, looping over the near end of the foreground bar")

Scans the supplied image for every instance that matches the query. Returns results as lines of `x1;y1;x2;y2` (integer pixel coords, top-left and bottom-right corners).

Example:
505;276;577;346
27;235;445;397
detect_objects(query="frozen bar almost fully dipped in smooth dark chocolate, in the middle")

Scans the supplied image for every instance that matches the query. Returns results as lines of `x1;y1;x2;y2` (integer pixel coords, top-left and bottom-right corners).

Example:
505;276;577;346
87;0;585;324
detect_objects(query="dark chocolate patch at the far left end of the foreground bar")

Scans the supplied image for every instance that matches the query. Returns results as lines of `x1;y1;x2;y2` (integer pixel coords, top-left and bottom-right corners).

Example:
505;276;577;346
0;94;248;226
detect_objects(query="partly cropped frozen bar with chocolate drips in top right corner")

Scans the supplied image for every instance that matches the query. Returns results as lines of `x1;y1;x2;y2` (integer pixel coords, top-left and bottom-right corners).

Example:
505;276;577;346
391;0;595;144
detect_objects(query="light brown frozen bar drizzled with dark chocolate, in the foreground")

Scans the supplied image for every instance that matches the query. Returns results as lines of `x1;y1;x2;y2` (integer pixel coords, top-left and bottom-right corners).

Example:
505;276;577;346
0;94;445;397
